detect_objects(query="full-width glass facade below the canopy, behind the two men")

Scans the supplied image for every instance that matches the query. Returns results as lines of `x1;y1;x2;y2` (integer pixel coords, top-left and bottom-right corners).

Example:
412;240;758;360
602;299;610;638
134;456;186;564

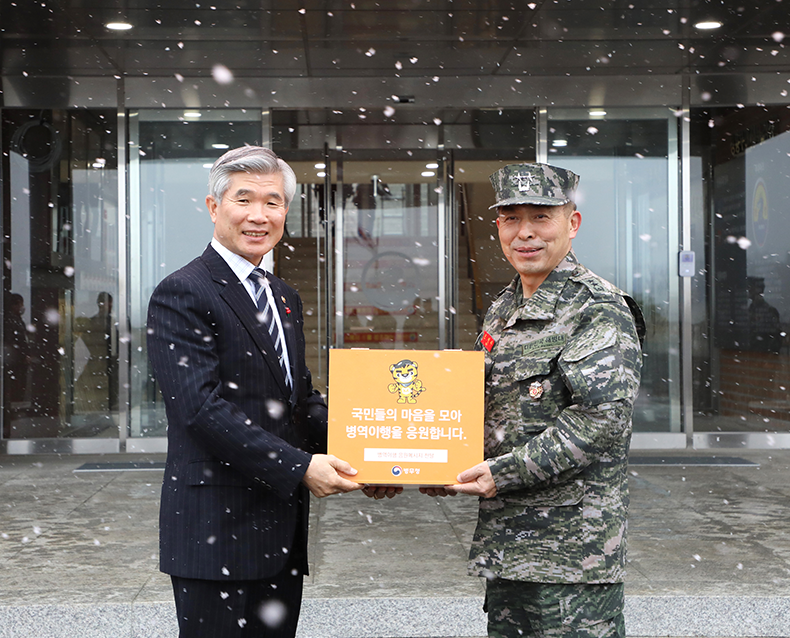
2;106;790;450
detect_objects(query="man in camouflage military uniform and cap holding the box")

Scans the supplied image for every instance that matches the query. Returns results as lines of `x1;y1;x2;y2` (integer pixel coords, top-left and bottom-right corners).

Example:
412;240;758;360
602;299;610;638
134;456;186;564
423;164;644;638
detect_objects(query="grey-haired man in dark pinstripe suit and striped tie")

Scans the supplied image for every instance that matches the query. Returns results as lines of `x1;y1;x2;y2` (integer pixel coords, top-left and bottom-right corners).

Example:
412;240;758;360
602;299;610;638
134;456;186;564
148;146;361;638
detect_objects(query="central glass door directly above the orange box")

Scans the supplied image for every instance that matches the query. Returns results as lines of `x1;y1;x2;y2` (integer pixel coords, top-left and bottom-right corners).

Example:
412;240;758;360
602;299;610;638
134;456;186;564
333;152;446;350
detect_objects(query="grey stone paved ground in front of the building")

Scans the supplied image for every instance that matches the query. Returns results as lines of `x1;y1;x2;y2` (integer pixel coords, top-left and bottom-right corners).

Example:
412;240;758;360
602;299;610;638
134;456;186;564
0;451;790;638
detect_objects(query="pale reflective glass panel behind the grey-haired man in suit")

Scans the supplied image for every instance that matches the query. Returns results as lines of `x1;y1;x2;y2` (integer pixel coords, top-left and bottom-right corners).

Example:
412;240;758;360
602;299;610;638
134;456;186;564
129;109;262;437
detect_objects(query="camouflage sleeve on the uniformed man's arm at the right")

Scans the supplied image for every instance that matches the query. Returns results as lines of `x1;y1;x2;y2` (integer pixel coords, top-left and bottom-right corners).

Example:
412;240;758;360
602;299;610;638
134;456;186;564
488;303;641;493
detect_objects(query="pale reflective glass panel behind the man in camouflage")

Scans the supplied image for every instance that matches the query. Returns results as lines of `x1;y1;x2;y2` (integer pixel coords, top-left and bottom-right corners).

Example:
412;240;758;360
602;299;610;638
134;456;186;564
548;110;680;432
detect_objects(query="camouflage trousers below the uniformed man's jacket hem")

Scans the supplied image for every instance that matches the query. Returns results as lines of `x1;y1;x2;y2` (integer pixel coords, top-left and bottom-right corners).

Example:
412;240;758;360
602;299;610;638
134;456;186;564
484;578;625;638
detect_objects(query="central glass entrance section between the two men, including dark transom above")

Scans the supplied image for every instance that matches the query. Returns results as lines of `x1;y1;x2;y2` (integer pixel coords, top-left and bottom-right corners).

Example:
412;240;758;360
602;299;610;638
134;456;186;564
272;107;535;389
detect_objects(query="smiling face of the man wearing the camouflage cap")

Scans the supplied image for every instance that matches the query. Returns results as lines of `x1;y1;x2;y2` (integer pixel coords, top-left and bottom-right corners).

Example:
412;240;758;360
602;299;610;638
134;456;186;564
496;204;582;297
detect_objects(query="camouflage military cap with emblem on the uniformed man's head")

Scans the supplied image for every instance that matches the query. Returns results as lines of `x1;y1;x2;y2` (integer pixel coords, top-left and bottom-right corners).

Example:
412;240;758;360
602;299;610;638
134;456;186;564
489;164;579;209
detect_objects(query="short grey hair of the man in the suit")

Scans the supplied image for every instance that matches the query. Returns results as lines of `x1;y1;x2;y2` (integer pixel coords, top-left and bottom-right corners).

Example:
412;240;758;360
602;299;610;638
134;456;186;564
208;146;296;207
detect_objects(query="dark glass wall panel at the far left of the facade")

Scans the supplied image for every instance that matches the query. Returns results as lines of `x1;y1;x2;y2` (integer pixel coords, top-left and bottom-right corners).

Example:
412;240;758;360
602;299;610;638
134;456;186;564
2;109;119;439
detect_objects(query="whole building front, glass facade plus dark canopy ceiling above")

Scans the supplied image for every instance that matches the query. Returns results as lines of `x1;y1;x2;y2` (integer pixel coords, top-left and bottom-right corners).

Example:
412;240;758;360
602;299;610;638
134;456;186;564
0;0;790;453
